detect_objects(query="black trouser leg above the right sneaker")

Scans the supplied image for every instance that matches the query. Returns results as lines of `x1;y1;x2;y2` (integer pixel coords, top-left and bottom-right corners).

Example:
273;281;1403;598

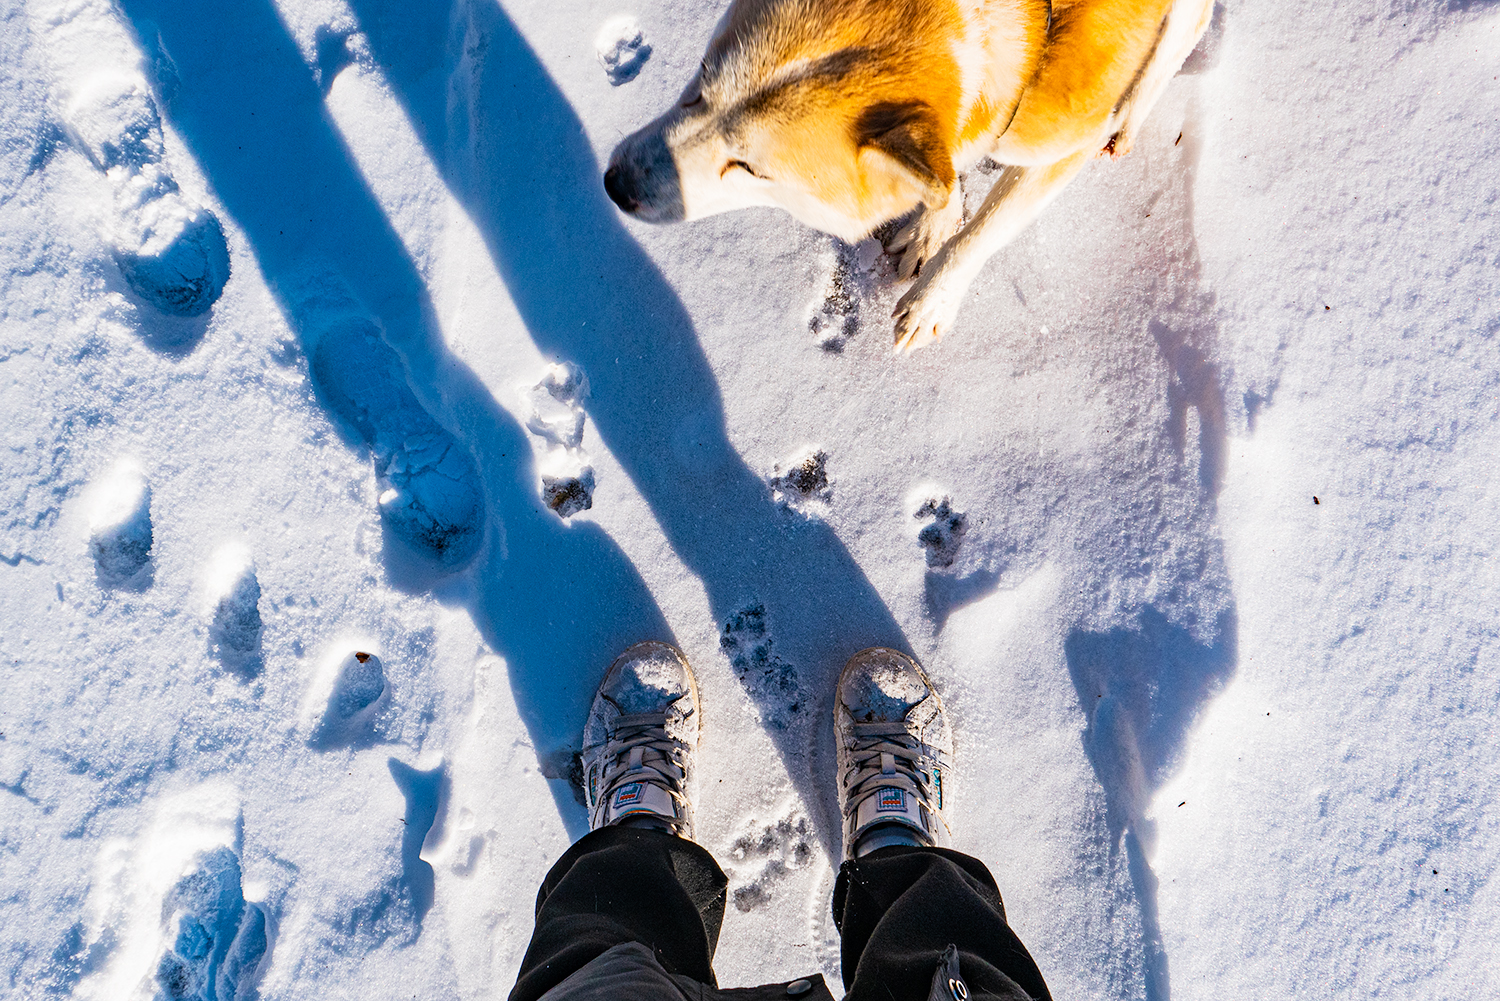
834;846;1052;1001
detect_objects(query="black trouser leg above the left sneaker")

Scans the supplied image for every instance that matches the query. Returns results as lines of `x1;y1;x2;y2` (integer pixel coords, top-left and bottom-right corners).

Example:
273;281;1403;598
510;827;729;1001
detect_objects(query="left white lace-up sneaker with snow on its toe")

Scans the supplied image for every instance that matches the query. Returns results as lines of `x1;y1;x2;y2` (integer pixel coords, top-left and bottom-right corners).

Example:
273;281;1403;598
582;642;699;837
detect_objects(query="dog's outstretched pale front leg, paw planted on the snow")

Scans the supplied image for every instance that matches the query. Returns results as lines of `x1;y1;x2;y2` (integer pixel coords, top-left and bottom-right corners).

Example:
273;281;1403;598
893;149;1094;351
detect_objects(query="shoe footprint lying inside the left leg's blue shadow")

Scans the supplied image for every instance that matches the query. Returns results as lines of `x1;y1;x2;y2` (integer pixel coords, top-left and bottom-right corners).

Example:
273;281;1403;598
308;311;485;570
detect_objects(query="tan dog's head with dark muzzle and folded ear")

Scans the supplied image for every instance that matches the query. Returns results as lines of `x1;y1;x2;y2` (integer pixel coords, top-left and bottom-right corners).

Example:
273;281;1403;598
605;0;959;240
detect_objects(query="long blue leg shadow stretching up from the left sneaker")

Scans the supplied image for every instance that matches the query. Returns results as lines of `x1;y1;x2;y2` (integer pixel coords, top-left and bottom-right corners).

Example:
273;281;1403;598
123;0;671;836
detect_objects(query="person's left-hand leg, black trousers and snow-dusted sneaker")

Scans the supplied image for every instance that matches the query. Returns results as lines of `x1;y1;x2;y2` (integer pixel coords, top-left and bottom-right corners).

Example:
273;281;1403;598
510;642;728;1001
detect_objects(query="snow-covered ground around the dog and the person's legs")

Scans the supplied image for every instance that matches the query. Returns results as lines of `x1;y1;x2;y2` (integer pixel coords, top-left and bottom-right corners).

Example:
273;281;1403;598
0;0;1500;1001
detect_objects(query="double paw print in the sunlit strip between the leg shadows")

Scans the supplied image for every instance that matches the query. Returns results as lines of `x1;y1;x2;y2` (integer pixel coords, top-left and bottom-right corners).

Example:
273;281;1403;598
525;362;594;518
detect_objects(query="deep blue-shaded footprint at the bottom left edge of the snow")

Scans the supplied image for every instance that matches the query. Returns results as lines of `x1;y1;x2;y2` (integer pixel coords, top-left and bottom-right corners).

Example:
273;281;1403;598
156;848;270;1001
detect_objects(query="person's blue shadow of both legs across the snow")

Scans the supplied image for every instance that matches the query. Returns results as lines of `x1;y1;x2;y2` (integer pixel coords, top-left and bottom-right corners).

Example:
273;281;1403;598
123;0;908;854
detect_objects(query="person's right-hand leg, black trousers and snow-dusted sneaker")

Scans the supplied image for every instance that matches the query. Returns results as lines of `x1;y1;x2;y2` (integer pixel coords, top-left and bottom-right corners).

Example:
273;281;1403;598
834;648;1050;1001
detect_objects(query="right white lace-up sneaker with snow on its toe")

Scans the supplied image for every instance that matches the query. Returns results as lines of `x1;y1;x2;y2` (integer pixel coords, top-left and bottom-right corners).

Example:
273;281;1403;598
834;647;953;858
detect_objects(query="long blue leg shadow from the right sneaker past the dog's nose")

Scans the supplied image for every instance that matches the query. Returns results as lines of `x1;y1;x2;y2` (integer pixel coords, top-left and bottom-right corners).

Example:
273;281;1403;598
342;0;909;849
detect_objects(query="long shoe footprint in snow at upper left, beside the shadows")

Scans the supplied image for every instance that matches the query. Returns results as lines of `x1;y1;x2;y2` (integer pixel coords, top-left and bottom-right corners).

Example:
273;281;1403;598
65;72;230;317
